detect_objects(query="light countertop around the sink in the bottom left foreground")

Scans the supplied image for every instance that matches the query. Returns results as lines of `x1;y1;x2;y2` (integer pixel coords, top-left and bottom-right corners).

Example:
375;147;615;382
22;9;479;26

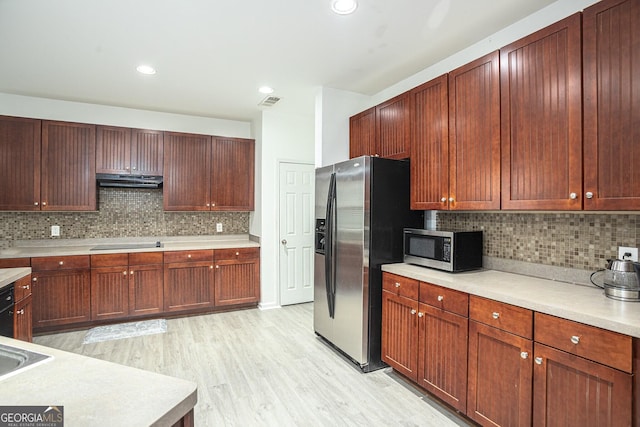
0;337;197;427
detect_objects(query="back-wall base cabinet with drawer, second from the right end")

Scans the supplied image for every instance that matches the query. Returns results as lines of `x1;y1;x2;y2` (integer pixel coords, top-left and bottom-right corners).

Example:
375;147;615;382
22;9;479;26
164;250;214;312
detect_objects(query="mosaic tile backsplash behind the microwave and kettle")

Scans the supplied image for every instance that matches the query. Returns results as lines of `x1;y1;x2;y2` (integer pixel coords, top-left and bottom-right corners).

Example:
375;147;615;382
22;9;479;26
436;211;640;270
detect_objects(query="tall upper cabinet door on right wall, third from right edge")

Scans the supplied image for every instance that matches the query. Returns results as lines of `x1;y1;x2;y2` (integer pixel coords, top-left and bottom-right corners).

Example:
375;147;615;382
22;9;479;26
449;51;500;210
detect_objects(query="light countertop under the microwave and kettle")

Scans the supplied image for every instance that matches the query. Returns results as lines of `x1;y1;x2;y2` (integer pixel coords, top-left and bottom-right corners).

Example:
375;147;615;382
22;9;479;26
382;264;640;338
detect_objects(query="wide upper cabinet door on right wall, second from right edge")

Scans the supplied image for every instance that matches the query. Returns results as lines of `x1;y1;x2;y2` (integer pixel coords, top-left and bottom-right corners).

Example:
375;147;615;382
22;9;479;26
500;13;582;210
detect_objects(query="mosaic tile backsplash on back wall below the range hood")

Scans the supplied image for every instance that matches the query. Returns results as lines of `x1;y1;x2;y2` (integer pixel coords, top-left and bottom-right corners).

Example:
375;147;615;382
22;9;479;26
0;188;249;247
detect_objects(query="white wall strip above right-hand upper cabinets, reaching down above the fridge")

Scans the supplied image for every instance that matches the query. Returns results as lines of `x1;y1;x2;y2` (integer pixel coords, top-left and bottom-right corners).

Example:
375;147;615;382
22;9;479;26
316;0;599;160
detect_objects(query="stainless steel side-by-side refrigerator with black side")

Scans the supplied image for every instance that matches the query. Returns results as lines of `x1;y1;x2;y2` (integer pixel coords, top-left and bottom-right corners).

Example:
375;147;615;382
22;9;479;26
313;156;424;372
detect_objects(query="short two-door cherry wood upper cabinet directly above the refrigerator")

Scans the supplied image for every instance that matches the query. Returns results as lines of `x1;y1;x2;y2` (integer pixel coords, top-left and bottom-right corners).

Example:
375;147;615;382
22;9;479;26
349;92;411;159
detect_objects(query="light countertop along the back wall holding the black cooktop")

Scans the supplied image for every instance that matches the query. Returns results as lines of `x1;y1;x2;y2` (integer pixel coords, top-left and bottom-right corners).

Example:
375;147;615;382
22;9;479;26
0;234;260;258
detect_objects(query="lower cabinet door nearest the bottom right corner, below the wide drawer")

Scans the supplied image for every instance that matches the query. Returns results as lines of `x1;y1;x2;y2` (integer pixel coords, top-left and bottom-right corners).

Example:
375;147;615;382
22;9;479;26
533;343;633;427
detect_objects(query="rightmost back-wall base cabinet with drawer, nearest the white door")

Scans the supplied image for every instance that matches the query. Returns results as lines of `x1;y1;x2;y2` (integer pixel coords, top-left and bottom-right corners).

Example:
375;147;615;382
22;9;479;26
214;248;260;307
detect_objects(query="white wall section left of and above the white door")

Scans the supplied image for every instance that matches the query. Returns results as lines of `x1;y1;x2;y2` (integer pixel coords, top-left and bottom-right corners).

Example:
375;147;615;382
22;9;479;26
256;110;314;308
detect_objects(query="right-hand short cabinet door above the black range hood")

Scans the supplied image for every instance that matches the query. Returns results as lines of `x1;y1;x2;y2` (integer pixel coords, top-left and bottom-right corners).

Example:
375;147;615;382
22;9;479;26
131;129;164;175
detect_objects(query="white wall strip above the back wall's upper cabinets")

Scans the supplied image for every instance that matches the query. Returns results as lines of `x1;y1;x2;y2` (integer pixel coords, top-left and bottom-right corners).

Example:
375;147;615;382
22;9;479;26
0;93;252;138
